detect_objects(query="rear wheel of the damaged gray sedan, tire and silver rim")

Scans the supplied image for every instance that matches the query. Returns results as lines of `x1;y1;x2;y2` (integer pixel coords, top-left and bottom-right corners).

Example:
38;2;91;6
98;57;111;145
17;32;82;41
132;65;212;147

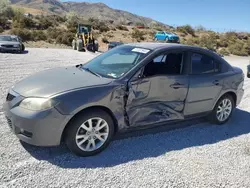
209;95;235;125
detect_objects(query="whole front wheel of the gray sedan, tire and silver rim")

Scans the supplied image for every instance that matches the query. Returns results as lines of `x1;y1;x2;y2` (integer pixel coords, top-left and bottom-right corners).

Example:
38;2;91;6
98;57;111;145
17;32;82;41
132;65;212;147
66;109;114;157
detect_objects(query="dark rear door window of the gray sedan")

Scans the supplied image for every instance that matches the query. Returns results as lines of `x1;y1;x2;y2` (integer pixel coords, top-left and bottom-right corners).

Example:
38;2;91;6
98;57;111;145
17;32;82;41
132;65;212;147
191;53;219;74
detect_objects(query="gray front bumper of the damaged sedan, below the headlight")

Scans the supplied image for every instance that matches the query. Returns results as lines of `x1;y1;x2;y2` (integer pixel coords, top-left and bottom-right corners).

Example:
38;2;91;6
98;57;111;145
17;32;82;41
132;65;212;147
4;94;70;146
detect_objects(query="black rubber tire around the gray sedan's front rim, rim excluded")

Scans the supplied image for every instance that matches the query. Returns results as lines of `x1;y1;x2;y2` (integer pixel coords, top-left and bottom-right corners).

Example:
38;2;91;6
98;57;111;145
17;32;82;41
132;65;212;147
65;109;114;157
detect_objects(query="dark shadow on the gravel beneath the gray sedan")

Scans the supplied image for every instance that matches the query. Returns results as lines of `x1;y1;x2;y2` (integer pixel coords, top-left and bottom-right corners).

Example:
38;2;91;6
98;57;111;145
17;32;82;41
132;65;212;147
22;109;250;168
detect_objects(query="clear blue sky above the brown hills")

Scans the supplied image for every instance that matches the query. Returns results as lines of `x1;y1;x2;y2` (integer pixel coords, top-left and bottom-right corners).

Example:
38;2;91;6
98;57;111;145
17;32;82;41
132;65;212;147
62;0;250;32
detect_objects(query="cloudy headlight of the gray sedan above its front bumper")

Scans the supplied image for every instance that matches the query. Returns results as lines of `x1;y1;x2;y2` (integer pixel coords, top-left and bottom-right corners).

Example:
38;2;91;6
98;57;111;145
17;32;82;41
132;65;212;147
19;98;57;111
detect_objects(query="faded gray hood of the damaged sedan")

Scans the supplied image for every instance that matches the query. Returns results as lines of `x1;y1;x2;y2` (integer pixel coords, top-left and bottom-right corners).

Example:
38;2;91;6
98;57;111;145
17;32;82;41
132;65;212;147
12;67;112;97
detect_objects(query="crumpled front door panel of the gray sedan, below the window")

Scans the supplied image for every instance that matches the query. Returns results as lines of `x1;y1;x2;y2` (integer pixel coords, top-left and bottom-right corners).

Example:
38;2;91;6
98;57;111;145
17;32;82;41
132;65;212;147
126;75;189;126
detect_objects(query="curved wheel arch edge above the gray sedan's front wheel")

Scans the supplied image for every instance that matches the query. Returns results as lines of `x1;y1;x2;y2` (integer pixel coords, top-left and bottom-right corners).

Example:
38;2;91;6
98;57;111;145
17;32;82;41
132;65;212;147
61;106;118;142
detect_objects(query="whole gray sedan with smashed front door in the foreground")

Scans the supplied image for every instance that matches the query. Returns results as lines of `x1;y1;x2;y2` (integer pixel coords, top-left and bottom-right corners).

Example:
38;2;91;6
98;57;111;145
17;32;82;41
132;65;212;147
4;43;244;156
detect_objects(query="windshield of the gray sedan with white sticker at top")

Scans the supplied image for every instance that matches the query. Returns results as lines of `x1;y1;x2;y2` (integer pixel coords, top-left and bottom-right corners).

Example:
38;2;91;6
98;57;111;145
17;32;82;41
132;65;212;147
83;45;150;78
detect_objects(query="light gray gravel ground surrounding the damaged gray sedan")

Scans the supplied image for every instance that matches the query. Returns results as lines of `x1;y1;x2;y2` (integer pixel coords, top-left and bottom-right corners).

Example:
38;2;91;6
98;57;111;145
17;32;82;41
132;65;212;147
0;48;250;188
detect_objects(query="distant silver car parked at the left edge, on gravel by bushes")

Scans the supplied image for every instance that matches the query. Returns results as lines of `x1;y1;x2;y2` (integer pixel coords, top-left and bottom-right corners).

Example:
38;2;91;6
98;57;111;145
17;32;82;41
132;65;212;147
0;35;25;52
